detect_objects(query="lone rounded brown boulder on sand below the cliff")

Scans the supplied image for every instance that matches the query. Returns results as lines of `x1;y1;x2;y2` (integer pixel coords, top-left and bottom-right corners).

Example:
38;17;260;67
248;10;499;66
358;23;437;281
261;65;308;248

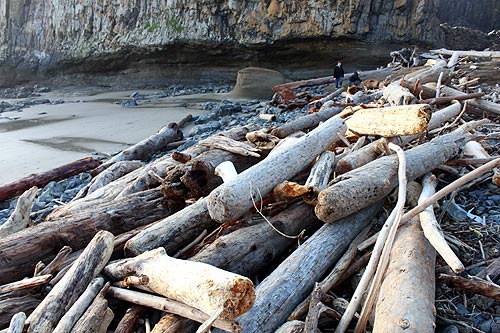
229;67;285;99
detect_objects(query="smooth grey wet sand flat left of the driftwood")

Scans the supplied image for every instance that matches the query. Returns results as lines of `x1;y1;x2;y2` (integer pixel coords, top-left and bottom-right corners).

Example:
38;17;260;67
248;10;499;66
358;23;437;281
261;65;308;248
0;90;226;184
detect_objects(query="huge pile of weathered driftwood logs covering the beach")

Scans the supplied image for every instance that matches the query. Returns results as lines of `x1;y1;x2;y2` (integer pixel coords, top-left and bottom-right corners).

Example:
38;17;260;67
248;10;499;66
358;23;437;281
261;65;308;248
0;48;500;333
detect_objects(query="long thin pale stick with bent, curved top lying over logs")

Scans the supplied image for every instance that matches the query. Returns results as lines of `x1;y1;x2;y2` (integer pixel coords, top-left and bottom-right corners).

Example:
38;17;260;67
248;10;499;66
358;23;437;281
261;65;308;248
354;143;407;333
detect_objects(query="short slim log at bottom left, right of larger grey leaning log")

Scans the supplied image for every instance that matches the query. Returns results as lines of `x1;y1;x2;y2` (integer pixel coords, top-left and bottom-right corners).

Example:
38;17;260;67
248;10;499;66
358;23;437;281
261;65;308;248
52;277;104;333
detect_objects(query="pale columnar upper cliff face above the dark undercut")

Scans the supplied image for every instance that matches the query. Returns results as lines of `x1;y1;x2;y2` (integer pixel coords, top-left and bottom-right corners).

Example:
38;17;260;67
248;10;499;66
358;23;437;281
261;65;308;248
0;0;443;83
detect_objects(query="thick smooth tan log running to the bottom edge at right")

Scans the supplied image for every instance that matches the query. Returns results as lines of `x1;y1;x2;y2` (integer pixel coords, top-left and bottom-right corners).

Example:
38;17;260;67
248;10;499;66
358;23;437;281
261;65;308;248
373;184;436;333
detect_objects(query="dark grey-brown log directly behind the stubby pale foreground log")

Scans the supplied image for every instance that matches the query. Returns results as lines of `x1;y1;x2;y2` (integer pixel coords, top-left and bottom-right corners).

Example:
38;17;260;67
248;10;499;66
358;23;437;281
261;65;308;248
189;203;319;276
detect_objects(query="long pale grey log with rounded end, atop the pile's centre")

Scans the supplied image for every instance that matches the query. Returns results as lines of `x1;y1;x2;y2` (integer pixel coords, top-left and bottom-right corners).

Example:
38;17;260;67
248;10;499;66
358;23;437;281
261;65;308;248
208;118;346;222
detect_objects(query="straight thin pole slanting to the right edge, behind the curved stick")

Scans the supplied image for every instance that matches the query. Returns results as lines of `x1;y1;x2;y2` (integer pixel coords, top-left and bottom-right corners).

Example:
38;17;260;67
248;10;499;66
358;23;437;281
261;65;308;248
358;158;500;251
